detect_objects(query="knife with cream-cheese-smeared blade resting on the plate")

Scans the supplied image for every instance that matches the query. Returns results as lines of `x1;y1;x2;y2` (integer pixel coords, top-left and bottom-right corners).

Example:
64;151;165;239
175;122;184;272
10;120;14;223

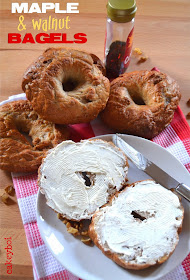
112;134;190;201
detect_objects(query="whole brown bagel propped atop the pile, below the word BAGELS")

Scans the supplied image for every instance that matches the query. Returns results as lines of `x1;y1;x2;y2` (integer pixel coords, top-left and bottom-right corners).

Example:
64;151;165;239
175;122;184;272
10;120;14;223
22;48;110;124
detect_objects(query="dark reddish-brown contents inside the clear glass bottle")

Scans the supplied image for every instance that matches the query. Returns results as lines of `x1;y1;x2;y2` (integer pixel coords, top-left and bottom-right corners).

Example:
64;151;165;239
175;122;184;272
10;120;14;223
106;41;126;80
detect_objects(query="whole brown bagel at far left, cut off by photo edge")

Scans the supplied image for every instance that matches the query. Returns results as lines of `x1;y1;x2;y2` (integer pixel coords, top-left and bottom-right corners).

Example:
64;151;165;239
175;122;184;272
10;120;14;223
0;100;69;172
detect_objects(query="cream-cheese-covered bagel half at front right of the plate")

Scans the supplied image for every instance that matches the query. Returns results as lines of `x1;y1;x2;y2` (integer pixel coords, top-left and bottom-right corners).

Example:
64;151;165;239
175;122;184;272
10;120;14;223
89;180;184;270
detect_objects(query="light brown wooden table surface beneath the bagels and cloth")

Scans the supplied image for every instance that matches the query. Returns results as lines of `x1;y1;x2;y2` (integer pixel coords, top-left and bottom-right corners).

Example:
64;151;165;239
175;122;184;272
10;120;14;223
0;0;190;280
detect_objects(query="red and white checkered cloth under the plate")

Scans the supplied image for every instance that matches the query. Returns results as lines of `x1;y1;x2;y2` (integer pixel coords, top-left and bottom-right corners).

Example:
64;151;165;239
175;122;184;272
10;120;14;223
13;107;190;280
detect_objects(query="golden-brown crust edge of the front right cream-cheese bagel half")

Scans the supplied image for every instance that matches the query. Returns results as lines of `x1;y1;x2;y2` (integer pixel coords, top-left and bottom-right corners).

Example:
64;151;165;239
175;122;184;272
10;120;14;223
88;181;184;270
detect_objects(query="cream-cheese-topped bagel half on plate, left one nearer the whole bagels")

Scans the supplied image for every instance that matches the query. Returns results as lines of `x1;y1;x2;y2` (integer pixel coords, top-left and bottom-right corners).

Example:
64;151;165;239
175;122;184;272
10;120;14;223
38;139;128;221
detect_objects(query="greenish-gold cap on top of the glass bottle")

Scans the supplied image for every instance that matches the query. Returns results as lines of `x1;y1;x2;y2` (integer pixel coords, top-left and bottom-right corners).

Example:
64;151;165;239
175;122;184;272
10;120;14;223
107;0;137;22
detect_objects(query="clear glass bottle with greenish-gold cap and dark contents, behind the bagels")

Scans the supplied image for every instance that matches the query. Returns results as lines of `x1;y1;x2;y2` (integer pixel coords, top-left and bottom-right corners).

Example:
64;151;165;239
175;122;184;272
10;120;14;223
104;0;137;80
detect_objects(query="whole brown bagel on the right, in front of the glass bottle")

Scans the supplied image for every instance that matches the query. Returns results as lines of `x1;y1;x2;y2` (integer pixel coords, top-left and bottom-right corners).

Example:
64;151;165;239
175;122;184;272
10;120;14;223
101;70;181;139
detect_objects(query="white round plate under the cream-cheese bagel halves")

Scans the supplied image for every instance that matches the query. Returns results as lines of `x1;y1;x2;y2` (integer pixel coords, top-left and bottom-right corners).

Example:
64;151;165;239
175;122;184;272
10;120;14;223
37;135;190;280
